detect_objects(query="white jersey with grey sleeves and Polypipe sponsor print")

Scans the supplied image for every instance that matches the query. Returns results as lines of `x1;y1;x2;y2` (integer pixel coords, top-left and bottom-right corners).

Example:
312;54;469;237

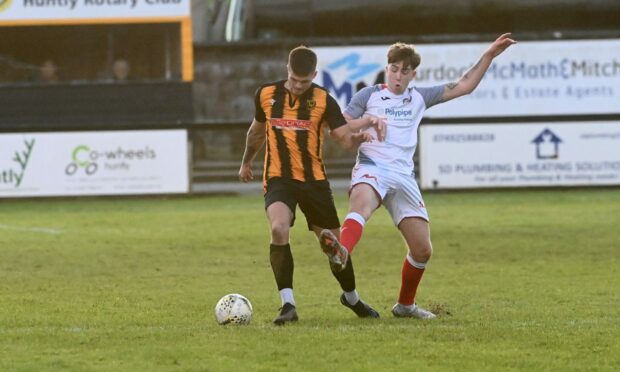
344;84;444;174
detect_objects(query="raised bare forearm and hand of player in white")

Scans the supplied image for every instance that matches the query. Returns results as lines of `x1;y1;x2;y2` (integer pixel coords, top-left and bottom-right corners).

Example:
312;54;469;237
441;33;517;102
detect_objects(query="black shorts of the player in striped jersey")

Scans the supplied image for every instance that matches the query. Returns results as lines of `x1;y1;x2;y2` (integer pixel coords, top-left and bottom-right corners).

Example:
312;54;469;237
265;178;340;230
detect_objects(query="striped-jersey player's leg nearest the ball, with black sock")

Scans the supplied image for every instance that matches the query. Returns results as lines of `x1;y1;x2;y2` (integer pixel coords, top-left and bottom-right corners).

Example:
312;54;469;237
265;182;298;325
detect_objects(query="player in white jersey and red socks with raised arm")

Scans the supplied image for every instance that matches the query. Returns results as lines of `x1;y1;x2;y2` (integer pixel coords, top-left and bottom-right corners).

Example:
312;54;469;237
320;33;516;319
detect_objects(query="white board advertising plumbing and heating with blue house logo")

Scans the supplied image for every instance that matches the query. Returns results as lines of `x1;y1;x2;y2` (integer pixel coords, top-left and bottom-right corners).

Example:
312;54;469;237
419;121;620;189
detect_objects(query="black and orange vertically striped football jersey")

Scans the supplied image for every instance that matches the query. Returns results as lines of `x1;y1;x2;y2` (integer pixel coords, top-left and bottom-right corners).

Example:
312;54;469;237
254;80;346;186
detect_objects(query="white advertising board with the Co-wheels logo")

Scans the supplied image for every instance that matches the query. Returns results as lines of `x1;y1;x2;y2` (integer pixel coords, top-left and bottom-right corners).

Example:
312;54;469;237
0;130;189;197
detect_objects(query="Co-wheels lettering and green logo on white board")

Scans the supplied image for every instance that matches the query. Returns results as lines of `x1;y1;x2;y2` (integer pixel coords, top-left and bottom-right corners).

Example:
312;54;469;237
65;145;157;176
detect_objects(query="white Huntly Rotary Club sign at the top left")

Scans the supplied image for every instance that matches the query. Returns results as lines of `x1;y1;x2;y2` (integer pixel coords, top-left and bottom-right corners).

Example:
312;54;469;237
0;0;190;25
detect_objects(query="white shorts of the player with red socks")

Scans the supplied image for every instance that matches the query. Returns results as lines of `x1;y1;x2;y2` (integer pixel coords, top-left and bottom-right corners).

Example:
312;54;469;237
351;164;430;227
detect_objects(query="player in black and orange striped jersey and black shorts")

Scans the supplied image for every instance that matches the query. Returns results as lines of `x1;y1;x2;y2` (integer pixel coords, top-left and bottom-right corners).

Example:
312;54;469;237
239;46;379;325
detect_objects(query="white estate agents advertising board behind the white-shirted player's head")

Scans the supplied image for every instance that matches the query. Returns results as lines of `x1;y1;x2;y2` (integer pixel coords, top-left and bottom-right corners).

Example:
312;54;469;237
315;40;620;118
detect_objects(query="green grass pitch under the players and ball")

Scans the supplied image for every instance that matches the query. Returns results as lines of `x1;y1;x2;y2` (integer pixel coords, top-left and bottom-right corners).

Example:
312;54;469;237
0;189;620;371
